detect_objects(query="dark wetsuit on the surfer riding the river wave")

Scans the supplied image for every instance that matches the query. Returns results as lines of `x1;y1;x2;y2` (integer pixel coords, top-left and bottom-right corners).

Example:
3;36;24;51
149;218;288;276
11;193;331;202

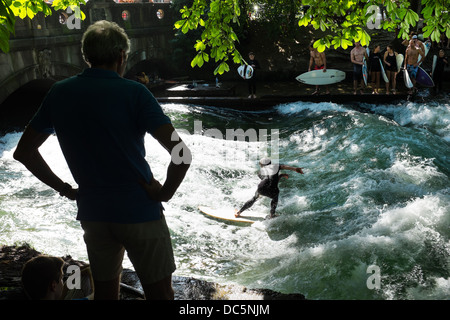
239;164;281;216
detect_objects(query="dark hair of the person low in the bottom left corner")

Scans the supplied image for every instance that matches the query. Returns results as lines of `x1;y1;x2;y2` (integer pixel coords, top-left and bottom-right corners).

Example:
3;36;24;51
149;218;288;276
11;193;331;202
22;255;64;300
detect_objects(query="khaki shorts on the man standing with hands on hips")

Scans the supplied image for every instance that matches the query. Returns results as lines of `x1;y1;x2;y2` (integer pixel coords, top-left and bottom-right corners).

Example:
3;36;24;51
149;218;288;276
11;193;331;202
81;213;176;285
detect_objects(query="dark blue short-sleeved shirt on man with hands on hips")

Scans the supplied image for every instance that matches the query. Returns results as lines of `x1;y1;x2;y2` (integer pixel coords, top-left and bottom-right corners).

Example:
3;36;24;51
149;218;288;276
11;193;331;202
30;68;170;223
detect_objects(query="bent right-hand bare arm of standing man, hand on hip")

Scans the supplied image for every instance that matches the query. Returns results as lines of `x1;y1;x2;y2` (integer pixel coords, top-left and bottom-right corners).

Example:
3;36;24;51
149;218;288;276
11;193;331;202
143;124;192;202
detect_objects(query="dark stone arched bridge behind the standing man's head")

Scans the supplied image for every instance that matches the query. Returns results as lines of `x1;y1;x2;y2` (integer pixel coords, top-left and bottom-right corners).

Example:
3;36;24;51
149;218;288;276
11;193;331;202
0;0;174;130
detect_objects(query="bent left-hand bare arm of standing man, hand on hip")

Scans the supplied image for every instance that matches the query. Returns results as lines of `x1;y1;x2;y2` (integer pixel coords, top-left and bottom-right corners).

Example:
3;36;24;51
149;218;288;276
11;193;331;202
14;126;78;200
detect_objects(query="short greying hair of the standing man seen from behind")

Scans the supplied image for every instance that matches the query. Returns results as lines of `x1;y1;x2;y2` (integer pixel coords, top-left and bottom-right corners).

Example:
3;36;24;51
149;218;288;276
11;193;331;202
81;20;130;66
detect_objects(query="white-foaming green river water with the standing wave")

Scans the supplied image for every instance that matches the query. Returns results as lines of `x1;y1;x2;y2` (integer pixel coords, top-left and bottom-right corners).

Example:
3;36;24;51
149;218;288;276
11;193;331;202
0;96;450;299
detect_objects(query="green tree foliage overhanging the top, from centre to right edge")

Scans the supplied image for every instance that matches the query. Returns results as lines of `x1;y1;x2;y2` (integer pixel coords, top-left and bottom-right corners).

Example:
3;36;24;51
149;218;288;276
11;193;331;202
175;0;450;74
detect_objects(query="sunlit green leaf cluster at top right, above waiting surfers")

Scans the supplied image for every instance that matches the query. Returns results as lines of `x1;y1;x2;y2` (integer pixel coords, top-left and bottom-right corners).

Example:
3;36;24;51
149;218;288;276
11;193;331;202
298;0;450;51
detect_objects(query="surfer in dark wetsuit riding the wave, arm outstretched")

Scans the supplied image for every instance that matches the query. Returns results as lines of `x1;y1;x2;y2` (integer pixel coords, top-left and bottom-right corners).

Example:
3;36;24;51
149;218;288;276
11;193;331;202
235;158;303;218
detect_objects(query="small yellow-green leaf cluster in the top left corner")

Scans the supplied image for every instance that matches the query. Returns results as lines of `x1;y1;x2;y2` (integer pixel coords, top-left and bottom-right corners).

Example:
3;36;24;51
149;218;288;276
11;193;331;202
0;0;86;52
